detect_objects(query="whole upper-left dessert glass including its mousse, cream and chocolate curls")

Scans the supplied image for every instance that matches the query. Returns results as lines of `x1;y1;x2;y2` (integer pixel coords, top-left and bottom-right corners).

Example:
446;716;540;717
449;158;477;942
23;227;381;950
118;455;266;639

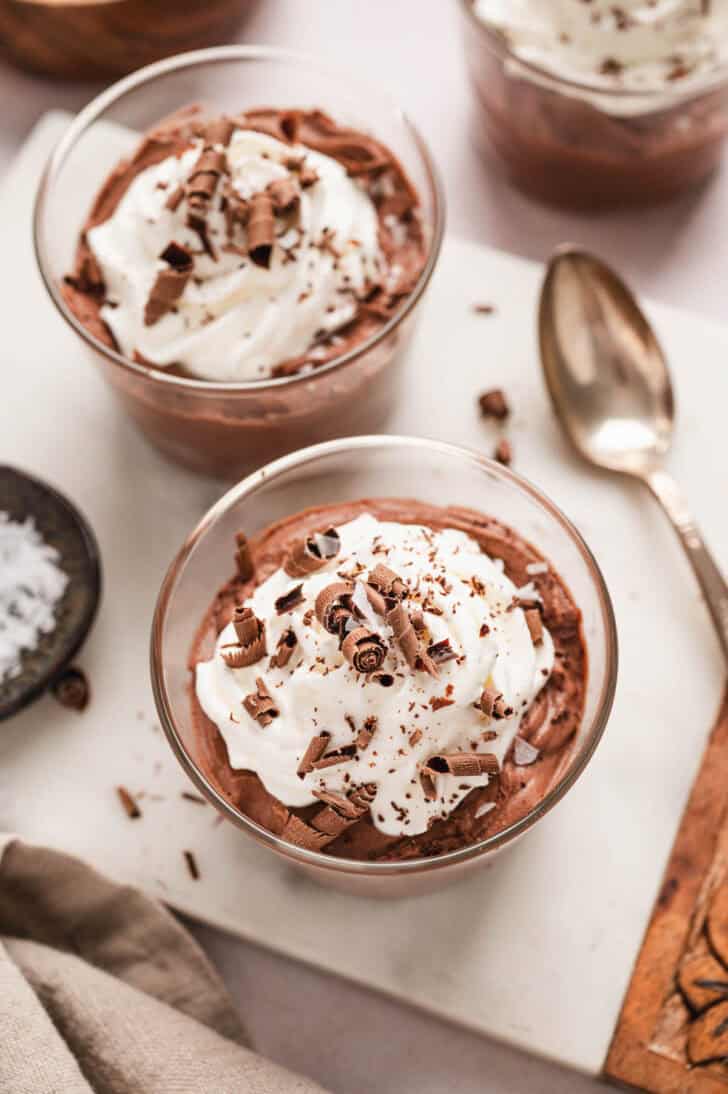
35;46;443;478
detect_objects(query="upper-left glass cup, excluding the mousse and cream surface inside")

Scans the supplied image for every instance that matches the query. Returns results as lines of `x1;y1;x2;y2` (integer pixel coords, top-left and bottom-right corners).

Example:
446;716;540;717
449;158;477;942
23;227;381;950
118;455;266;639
34;46;444;479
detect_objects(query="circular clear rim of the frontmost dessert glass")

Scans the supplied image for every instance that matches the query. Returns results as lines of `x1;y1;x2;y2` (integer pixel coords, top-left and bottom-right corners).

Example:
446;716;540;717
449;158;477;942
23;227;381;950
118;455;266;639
150;435;617;877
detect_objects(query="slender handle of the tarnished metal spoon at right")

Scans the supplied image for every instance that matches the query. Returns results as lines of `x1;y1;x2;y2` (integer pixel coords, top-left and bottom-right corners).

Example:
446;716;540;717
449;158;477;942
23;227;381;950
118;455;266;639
646;468;728;661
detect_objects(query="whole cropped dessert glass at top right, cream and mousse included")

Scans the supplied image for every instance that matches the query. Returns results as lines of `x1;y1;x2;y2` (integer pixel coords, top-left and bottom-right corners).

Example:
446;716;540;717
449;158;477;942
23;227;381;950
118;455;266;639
458;0;728;209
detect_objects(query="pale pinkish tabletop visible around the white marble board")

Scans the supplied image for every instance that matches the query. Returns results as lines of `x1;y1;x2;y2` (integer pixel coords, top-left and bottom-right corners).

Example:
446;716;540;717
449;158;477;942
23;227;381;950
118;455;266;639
0;0;728;1094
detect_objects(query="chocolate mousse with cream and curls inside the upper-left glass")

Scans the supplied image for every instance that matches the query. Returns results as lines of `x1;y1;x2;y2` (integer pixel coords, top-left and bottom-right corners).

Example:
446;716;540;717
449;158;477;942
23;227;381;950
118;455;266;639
63;108;428;383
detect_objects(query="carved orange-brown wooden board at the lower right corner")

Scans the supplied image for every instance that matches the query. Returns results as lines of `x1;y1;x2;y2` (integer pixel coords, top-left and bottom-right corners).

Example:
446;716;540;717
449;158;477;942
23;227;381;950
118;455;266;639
604;693;728;1094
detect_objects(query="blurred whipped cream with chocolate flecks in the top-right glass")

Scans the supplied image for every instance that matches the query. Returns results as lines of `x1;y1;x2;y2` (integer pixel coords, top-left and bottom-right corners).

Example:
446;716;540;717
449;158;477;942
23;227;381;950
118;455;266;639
473;0;728;92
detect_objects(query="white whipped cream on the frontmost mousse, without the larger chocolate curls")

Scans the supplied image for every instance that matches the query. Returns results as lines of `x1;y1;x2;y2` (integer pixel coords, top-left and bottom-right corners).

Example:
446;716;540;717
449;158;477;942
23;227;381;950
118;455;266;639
196;513;554;836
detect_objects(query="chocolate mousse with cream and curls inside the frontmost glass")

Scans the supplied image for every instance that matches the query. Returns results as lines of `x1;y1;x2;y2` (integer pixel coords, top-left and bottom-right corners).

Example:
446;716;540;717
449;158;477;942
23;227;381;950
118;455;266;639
189;499;587;861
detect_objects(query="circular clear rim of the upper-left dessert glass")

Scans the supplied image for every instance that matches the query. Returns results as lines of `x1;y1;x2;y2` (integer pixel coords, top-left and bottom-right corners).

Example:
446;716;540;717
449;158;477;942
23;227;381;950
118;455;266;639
33;46;446;395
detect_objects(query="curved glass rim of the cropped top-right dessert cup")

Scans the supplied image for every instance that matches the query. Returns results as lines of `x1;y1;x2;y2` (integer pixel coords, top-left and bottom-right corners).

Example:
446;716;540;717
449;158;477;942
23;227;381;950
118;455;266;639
458;0;728;113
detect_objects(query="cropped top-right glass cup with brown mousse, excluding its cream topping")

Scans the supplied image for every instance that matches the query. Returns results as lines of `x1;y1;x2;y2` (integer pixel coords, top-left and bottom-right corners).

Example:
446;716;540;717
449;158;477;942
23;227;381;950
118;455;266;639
458;0;728;210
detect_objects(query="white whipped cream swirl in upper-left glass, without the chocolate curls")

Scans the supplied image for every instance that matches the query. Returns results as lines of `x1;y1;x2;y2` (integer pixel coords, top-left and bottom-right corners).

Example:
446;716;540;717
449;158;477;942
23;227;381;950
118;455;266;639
86;129;386;382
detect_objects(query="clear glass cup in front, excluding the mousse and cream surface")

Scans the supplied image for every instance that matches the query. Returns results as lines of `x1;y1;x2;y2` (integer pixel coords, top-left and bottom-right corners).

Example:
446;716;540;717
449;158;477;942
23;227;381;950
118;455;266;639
151;437;617;897
